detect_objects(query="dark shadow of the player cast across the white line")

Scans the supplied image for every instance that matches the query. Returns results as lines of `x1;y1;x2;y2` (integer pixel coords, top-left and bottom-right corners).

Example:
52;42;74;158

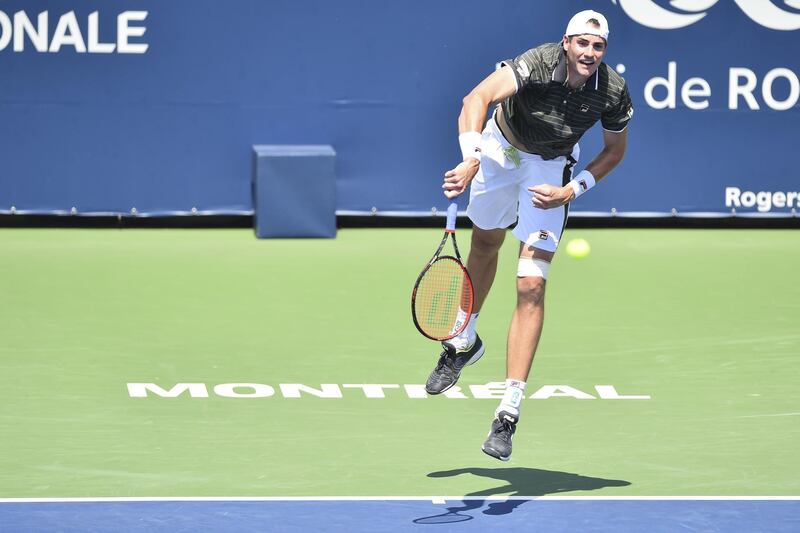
414;467;630;524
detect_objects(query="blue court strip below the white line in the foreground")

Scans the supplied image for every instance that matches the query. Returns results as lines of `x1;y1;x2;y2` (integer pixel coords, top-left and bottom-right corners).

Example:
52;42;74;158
0;497;800;532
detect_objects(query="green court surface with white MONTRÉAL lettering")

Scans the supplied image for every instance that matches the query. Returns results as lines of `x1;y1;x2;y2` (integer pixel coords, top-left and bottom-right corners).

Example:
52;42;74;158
0;229;800;498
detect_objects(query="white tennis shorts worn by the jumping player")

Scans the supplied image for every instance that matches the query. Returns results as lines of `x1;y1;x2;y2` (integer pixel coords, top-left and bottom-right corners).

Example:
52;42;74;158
467;117;580;252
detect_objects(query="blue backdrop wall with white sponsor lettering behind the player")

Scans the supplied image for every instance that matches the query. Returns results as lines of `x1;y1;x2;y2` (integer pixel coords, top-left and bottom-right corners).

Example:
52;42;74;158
0;0;800;215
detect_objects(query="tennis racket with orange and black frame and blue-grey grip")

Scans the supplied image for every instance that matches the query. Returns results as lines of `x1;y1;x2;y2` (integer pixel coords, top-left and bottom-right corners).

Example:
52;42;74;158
411;201;473;341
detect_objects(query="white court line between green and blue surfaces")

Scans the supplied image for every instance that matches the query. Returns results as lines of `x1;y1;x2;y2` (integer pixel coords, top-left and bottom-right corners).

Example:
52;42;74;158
0;495;800;504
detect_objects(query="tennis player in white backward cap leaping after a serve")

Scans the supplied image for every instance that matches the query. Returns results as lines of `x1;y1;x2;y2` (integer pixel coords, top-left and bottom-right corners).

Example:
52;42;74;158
426;11;633;461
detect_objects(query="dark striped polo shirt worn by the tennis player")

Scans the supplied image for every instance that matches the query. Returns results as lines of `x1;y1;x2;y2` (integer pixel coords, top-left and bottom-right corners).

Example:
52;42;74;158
498;43;633;159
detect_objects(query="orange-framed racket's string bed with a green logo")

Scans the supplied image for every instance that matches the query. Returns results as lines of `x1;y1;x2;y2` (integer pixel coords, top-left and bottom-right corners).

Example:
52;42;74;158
415;257;473;340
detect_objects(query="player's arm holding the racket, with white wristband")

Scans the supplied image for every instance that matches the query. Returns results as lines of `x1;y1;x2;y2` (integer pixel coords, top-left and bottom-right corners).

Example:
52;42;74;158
442;66;517;198
